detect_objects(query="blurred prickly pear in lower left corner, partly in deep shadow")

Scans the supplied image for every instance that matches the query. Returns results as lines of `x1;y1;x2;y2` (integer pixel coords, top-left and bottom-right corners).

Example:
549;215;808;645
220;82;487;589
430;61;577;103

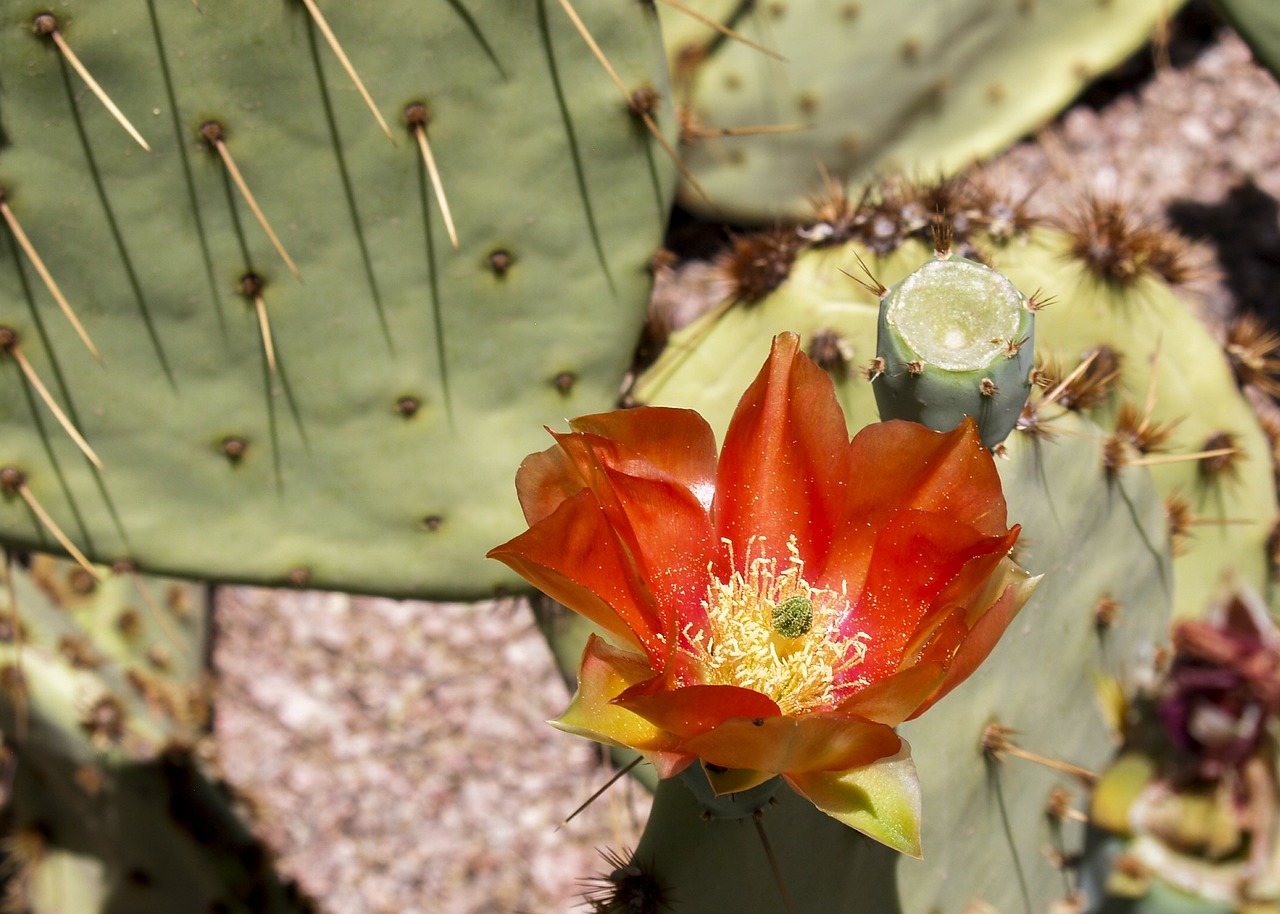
0;557;306;914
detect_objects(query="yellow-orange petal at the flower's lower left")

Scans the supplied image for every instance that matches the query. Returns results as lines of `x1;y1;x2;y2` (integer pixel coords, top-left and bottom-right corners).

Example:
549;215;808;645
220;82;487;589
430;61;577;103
550;635;694;777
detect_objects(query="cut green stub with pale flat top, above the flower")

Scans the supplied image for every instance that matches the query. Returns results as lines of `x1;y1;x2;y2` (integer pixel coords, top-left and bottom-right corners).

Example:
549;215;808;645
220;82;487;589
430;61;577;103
873;256;1036;448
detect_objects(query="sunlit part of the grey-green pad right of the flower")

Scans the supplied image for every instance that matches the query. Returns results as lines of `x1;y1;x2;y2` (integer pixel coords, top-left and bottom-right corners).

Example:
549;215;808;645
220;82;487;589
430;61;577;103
899;417;1172;914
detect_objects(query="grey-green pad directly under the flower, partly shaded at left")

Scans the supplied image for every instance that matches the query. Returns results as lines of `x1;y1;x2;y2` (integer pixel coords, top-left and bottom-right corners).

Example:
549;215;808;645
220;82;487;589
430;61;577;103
605;381;1172;914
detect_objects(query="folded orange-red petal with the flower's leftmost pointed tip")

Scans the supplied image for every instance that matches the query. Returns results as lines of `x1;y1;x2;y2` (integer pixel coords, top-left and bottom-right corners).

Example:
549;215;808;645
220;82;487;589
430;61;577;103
489;490;667;668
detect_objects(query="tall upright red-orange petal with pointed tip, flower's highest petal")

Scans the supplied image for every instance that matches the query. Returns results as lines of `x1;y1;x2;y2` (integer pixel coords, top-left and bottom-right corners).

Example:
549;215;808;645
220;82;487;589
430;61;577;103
713;333;849;577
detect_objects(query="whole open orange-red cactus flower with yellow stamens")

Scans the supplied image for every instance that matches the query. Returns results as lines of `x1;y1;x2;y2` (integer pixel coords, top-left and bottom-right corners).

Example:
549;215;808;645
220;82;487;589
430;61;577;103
489;334;1038;854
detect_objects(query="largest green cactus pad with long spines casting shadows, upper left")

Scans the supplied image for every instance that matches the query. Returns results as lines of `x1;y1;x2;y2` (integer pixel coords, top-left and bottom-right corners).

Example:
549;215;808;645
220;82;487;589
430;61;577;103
0;0;673;597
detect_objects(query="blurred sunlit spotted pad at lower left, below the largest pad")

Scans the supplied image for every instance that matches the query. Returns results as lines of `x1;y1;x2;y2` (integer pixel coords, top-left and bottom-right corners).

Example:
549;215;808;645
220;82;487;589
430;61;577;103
0;556;210;766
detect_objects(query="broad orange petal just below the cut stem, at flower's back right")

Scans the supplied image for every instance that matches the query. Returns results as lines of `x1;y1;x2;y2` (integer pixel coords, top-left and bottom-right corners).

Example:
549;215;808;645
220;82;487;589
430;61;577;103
845;419;1007;535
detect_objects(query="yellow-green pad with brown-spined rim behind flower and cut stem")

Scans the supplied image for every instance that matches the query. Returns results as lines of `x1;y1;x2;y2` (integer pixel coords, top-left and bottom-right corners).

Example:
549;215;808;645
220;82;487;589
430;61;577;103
634;228;1277;617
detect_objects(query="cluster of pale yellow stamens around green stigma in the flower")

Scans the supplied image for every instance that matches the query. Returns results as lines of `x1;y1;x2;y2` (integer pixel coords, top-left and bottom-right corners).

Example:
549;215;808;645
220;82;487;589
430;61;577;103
685;536;870;714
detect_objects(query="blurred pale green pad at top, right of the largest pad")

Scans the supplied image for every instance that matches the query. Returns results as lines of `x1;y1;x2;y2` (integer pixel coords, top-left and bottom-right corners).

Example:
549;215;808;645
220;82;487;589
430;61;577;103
662;0;1182;221
